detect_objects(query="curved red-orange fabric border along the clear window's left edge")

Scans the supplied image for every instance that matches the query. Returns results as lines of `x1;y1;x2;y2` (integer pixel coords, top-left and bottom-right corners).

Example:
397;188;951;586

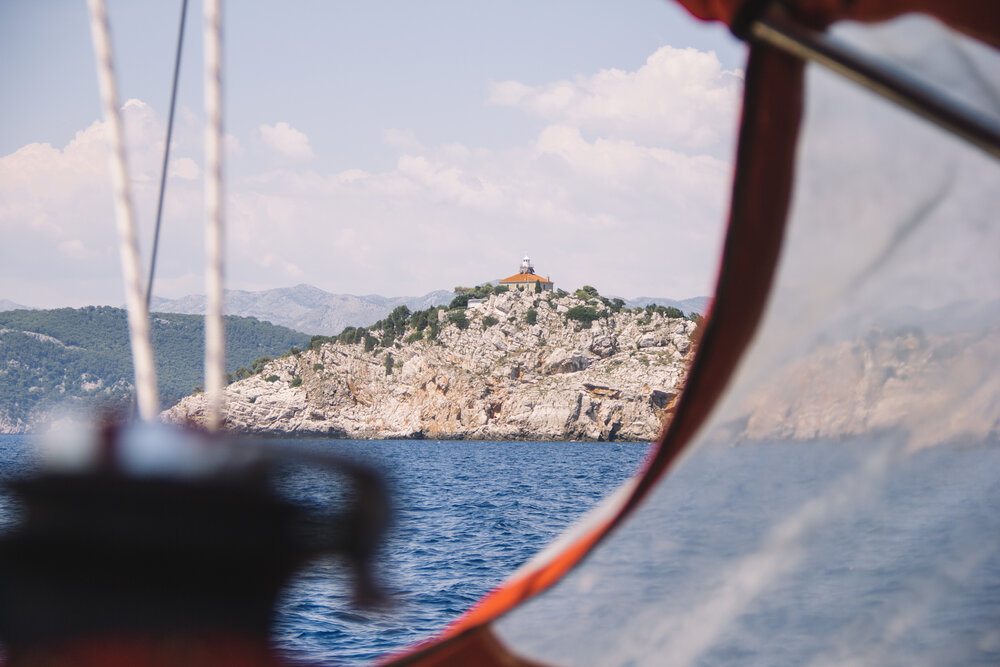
386;41;802;665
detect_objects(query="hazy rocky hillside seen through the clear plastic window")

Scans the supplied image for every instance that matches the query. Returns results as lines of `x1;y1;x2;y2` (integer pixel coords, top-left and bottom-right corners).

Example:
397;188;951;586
728;327;1000;449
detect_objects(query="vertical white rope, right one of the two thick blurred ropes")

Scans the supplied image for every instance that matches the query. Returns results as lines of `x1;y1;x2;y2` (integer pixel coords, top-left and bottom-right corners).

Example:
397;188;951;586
204;0;226;432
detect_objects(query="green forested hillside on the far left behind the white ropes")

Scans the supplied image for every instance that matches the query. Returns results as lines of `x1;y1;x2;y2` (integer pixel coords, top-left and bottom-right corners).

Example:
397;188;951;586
0;306;309;424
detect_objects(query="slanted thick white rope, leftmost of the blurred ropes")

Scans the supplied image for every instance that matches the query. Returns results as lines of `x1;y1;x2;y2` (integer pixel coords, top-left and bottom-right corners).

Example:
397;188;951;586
87;0;160;421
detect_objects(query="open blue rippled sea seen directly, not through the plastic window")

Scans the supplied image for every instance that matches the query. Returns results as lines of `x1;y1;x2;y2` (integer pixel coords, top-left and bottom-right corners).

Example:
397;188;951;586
0;435;649;665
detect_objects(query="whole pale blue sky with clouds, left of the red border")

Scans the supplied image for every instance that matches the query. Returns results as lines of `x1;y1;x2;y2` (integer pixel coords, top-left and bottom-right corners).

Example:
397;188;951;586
0;0;745;307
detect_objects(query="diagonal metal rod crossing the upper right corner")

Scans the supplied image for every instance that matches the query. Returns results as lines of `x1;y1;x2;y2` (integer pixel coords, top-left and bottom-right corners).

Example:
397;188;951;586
750;12;1000;158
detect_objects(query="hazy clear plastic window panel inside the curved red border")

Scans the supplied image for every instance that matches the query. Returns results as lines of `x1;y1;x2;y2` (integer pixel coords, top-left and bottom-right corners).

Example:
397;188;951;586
492;17;1000;665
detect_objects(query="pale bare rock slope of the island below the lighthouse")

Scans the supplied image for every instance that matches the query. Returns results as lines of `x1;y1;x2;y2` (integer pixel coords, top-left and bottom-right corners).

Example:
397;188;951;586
164;291;695;440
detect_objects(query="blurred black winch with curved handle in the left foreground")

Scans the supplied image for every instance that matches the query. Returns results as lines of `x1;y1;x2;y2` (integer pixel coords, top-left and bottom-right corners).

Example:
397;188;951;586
0;422;388;665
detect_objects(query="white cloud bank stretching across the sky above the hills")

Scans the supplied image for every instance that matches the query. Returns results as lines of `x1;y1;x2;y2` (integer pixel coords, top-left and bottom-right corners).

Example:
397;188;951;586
0;48;740;305
